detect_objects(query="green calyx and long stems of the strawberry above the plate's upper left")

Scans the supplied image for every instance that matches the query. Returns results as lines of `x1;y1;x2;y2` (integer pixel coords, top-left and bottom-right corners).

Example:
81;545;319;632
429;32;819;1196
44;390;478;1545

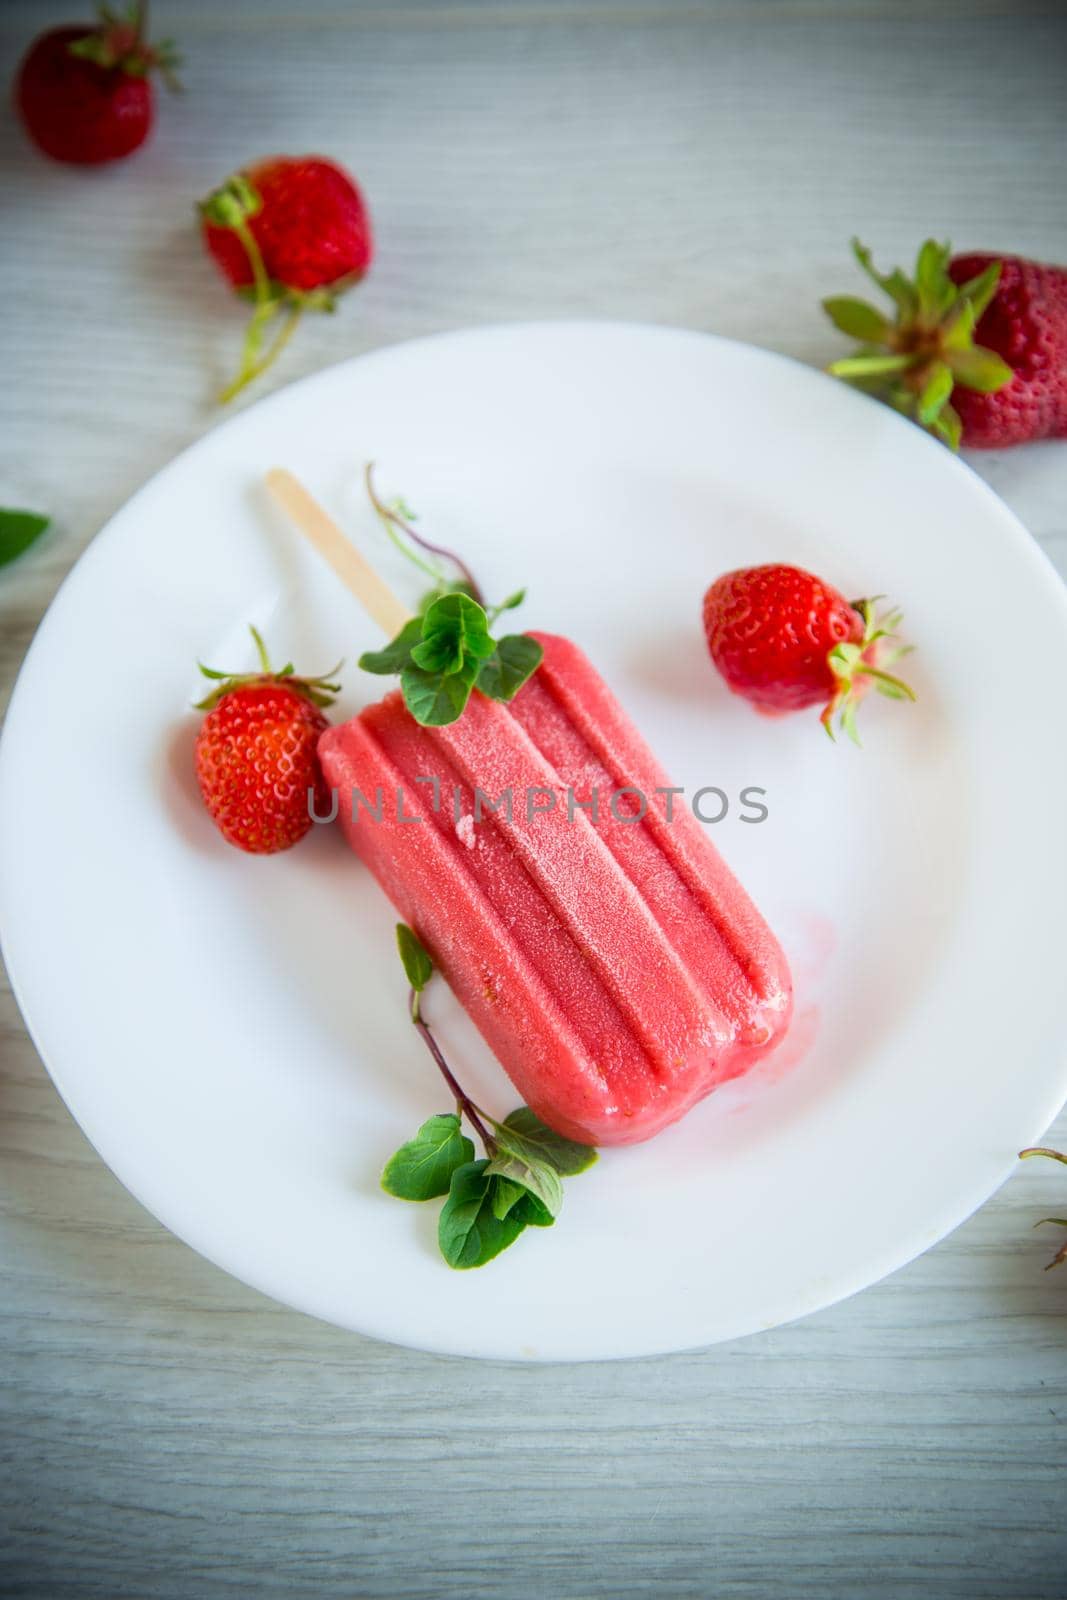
198;173;362;405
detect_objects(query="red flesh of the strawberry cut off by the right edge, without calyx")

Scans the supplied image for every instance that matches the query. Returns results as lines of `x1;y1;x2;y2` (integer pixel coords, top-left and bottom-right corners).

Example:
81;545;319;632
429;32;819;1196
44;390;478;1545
949;254;1067;446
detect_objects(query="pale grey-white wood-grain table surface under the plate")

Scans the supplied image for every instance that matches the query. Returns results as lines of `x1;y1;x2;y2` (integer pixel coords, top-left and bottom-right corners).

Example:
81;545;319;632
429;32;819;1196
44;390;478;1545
0;0;1067;1600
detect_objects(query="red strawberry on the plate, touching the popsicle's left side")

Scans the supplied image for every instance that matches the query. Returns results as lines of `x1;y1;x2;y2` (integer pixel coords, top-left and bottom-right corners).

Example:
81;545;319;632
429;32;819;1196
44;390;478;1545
195;627;338;856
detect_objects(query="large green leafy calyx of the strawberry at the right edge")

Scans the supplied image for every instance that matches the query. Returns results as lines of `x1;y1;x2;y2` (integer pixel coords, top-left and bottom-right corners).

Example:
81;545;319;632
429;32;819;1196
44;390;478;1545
822;238;1014;450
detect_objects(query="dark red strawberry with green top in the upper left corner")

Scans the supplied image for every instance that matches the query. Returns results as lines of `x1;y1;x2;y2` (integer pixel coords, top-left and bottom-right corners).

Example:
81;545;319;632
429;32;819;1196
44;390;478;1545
14;5;178;166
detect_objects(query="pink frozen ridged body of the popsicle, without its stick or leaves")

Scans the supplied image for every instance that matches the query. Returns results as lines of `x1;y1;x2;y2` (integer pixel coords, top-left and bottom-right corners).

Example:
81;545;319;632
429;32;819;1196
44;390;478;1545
318;634;792;1144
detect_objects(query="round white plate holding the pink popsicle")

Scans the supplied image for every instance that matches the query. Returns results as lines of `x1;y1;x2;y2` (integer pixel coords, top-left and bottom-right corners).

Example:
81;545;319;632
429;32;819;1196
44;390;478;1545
0;323;1067;1358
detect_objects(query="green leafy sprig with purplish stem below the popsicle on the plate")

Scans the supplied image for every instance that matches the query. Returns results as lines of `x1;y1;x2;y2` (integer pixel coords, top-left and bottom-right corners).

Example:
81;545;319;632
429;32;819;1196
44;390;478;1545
382;922;597;1270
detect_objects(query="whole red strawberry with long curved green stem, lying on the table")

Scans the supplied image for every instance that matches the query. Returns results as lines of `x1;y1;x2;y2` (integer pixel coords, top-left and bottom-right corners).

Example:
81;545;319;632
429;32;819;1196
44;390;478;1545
200;155;373;402
